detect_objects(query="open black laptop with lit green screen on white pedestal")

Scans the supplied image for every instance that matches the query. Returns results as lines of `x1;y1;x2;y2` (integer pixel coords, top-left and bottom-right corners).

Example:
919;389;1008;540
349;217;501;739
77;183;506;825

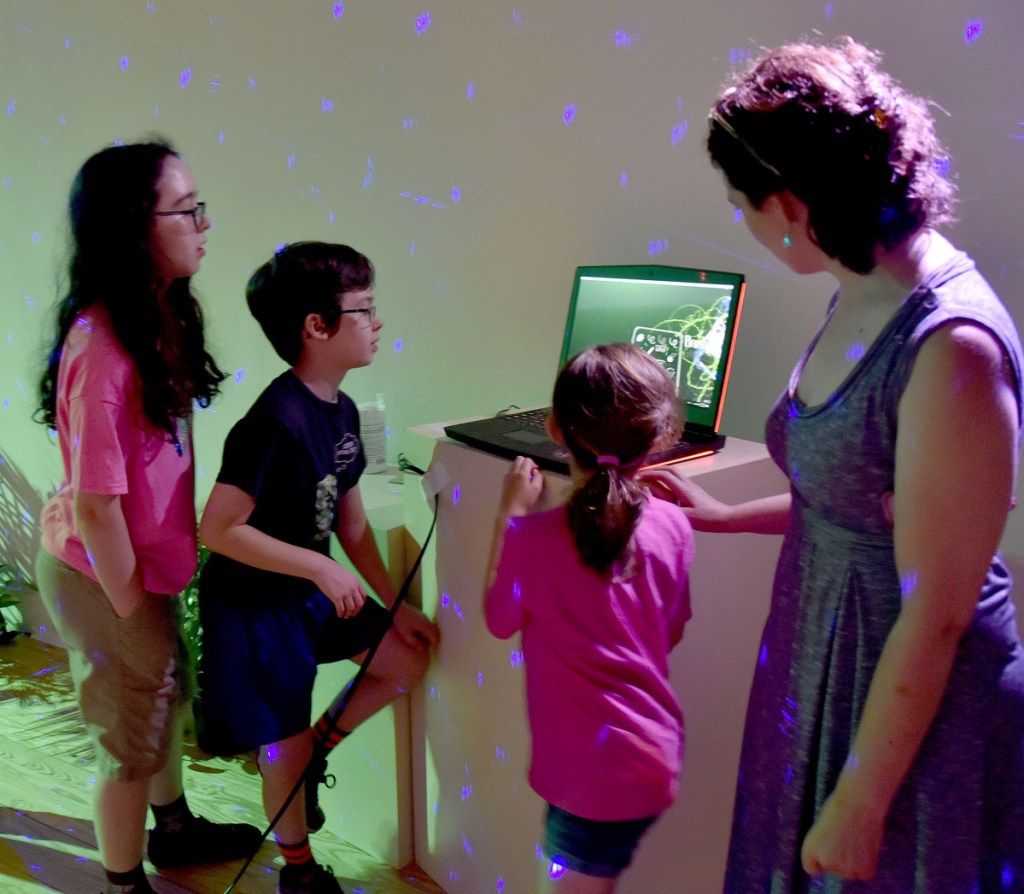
444;264;745;473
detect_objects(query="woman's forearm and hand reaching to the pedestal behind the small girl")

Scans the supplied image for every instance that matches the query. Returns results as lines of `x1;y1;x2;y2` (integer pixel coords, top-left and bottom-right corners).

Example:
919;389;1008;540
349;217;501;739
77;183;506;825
640;465;792;534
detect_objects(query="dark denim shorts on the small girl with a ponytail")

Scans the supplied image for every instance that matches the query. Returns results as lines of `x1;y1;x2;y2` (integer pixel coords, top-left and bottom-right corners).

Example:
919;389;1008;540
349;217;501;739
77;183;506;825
544;804;657;879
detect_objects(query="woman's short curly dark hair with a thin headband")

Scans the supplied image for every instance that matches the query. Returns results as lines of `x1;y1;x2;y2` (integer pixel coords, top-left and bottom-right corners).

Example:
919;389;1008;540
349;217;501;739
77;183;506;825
708;38;955;273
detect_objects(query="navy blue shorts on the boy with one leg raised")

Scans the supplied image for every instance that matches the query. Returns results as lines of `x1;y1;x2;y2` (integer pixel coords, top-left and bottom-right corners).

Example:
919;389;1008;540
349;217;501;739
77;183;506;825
196;592;390;756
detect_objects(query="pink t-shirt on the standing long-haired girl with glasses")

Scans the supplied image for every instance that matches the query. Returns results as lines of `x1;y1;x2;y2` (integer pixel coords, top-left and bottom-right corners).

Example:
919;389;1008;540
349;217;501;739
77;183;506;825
42;307;197;593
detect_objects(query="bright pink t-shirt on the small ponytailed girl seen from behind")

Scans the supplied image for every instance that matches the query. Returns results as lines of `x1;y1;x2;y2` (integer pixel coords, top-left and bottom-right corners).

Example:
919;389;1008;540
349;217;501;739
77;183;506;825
486;500;693;821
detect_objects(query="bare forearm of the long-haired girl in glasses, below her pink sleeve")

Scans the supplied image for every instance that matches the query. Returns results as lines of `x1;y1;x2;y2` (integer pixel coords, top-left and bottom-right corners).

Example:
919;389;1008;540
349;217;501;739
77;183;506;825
75;494;145;618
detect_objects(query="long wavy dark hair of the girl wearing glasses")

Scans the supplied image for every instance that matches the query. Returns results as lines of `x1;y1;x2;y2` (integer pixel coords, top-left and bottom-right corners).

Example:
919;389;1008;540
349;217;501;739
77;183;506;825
36;139;224;436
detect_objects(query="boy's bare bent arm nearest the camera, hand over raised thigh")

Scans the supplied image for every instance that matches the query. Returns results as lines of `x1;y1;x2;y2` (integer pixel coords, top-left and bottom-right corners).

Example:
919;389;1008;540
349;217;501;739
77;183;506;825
199;482;367;616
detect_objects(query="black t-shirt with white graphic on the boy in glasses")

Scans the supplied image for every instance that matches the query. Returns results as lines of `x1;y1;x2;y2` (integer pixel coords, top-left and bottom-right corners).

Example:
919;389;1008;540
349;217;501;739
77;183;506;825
202;370;367;604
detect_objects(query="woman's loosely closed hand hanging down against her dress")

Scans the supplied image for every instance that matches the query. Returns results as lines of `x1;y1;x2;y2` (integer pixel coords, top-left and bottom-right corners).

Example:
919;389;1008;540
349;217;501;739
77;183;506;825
800;780;886;881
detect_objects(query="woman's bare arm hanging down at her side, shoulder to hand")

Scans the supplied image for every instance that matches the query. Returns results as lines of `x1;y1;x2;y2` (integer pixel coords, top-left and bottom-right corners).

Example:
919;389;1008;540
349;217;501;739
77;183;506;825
803;324;1017;879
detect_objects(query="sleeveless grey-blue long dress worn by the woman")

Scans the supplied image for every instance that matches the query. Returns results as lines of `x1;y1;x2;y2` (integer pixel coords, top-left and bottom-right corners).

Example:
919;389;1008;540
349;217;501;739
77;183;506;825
725;255;1024;894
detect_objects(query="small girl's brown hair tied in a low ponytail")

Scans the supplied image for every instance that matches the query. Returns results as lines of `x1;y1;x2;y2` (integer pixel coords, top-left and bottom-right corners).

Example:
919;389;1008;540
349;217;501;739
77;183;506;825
552;344;682;577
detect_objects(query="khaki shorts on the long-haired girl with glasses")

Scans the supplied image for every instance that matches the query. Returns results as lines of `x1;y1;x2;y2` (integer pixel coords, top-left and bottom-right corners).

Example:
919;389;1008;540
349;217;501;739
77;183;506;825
36;550;195;782
